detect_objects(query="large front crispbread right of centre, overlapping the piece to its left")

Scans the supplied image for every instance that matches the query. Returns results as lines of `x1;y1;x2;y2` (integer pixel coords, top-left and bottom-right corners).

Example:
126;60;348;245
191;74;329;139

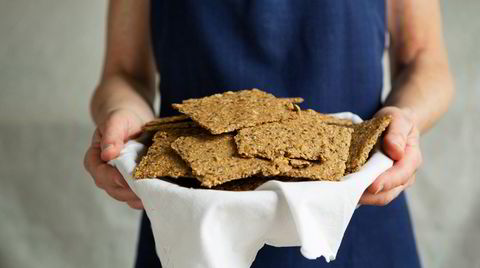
235;111;353;161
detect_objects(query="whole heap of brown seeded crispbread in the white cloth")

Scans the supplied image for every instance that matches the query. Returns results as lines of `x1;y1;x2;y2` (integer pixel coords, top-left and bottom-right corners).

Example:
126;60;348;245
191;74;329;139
134;89;391;190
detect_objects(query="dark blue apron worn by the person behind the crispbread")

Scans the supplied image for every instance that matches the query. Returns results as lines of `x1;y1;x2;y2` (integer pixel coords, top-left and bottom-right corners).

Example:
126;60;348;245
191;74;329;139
136;0;420;268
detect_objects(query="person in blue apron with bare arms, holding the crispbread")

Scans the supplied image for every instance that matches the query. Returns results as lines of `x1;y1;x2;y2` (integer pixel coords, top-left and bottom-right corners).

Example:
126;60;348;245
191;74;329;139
84;0;454;267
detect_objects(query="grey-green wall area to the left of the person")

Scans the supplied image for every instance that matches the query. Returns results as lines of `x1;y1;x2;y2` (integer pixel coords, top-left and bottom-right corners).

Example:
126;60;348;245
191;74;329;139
0;0;139;267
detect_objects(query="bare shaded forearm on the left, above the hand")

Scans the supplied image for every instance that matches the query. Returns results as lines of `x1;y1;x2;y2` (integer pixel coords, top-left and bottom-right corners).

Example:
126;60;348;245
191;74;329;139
90;0;155;125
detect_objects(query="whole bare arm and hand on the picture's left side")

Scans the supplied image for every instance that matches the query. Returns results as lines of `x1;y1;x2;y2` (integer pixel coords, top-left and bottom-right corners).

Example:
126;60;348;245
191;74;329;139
84;0;155;209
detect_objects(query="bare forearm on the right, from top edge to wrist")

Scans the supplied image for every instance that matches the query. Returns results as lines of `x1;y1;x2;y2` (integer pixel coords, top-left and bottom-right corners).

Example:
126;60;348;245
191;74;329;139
386;0;454;132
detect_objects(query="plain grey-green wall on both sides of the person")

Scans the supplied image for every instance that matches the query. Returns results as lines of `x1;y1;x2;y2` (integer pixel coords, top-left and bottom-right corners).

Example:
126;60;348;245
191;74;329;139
0;0;480;267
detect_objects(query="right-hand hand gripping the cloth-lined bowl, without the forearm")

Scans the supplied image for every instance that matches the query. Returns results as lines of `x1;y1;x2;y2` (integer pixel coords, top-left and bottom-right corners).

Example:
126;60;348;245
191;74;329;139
360;106;422;206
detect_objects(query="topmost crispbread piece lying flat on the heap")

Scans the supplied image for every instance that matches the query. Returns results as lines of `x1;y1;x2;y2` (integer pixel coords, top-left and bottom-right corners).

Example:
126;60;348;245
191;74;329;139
172;89;303;134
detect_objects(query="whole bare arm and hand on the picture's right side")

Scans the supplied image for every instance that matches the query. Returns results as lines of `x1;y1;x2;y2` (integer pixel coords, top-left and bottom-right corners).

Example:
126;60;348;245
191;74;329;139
360;0;455;205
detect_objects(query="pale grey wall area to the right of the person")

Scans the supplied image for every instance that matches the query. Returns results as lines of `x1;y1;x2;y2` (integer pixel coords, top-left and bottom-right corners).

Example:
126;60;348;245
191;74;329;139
409;0;480;267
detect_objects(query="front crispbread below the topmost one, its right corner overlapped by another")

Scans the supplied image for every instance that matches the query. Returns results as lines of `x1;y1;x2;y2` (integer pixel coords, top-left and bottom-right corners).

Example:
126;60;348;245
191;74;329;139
171;134;269;188
